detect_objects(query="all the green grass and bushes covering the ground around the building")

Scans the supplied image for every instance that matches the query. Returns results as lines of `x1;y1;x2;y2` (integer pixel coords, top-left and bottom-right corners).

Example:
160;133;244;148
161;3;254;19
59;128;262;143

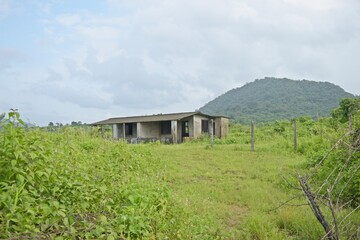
0;98;360;239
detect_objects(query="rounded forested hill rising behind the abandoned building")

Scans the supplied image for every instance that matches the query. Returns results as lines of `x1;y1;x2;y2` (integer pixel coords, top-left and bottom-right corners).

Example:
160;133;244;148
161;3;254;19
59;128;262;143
200;77;354;124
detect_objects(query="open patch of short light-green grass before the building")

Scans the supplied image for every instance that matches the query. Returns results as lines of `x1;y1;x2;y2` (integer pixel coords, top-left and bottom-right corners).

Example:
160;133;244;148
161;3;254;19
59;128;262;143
142;144;322;239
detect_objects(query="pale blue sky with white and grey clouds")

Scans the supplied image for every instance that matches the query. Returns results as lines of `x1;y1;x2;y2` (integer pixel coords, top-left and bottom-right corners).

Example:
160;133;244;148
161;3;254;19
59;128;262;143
0;0;360;126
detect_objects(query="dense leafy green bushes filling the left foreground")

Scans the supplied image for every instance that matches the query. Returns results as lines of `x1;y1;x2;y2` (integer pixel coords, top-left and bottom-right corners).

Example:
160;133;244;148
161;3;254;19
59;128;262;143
0;112;179;239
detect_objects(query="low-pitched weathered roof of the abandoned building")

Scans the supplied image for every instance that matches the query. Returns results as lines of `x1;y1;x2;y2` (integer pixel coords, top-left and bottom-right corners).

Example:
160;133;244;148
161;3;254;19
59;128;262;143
91;112;223;126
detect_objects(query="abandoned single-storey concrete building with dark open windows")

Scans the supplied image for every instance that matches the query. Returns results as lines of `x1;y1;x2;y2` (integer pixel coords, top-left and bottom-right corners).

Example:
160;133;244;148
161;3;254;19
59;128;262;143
92;112;229;143
